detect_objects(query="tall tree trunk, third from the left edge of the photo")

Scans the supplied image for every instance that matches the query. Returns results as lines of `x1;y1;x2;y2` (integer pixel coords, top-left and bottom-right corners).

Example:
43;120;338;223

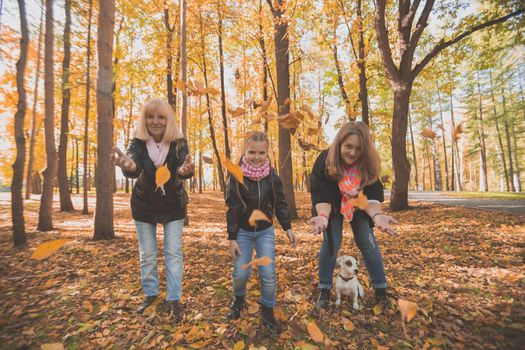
37;0;57;231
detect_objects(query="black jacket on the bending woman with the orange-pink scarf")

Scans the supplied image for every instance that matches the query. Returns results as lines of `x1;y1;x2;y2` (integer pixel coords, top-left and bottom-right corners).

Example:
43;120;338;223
310;149;385;214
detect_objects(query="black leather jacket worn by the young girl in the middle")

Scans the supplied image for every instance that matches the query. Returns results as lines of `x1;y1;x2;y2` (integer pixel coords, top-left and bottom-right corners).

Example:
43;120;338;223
225;168;292;240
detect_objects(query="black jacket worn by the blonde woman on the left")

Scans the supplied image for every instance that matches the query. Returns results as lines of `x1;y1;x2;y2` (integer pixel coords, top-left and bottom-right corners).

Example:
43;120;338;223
122;139;193;223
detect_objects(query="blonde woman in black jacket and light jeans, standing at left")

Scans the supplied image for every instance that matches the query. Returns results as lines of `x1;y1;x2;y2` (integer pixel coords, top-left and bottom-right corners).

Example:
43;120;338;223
111;99;195;323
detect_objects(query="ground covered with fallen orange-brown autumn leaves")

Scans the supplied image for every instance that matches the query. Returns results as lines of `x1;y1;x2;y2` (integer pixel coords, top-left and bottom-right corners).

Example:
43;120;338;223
0;192;525;349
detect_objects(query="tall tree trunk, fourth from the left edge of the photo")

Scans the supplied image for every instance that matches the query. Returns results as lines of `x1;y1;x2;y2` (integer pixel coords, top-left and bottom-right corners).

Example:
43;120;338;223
58;0;74;211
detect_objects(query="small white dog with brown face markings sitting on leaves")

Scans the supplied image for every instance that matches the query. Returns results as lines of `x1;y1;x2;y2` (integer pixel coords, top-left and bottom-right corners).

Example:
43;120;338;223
335;255;365;310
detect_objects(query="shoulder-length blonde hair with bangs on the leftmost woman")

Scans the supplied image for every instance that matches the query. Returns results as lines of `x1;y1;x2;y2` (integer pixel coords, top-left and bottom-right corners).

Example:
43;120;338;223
134;98;184;142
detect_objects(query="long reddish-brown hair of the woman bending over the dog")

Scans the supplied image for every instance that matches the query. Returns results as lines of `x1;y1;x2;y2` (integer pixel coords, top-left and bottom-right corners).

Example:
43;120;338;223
326;122;381;186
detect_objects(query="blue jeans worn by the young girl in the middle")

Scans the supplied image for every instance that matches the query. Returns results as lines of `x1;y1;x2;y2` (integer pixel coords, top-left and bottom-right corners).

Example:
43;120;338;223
232;226;277;307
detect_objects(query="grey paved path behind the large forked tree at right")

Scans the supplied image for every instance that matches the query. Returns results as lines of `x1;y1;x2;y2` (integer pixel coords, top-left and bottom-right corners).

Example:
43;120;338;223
385;191;525;215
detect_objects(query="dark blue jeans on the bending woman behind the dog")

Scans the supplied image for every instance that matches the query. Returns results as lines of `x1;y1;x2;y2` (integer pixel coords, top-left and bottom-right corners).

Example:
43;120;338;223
319;210;387;289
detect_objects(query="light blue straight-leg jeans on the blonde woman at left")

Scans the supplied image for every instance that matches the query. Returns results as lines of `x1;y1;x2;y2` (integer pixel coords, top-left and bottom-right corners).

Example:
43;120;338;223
135;219;184;300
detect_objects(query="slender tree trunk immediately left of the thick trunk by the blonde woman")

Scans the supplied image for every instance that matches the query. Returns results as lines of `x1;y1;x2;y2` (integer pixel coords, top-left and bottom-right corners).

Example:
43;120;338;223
82;0;93;214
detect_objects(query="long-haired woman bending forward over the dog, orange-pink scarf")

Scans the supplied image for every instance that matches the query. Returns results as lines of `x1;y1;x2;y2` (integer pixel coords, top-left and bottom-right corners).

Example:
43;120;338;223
308;122;397;309
